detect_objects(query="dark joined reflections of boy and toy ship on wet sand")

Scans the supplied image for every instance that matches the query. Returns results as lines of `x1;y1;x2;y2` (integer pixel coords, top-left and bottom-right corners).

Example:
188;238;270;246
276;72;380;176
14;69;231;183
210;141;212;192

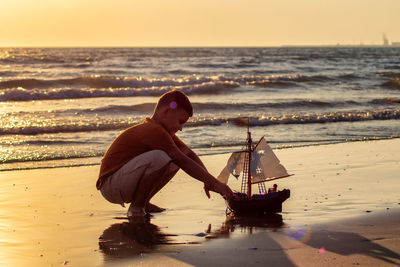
99;214;283;258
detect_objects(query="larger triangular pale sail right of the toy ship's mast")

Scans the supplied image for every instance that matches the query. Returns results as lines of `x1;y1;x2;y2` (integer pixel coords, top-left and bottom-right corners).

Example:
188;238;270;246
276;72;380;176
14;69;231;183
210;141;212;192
250;137;289;183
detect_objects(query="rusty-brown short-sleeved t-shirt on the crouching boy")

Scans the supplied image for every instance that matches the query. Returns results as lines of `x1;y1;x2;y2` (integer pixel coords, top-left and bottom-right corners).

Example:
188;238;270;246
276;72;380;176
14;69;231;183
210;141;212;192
96;118;185;189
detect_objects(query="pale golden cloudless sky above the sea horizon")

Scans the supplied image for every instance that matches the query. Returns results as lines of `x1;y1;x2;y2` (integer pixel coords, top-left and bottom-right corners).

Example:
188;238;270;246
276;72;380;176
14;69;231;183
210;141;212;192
0;0;400;47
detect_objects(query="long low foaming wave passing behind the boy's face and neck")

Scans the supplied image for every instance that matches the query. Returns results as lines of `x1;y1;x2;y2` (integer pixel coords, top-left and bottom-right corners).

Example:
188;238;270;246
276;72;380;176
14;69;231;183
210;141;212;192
0;109;400;135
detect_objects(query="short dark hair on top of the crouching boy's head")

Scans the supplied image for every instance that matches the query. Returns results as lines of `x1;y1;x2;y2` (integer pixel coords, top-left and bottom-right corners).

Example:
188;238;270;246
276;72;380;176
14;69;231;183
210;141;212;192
154;89;193;117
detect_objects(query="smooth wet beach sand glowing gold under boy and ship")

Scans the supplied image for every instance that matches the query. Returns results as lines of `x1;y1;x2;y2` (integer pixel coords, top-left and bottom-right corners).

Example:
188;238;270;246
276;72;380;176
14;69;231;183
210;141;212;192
0;139;400;266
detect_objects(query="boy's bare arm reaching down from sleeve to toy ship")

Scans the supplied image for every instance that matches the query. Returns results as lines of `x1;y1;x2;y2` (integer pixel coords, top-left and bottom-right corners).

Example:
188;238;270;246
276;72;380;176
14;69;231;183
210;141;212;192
169;148;233;198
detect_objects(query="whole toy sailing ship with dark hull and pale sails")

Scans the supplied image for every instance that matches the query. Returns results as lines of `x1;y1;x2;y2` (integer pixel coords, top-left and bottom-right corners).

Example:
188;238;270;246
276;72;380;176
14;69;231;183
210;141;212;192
218;122;291;215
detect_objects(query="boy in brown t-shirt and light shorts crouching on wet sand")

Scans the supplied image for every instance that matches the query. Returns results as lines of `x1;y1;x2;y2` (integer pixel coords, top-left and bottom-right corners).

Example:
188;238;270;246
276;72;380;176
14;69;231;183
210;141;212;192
96;90;233;217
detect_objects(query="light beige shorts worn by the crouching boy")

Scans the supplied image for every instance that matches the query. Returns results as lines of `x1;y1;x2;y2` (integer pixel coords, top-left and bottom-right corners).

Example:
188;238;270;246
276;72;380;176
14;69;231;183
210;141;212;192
100;150;178;207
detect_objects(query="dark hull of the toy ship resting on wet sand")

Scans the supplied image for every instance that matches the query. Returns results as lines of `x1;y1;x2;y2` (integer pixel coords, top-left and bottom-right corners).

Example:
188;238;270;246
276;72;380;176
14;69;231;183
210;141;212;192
227;189;290;215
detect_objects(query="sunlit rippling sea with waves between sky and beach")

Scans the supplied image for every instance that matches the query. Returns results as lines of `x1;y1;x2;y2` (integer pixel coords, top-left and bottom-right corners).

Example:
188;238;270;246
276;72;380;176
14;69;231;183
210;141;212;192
0;46;400;171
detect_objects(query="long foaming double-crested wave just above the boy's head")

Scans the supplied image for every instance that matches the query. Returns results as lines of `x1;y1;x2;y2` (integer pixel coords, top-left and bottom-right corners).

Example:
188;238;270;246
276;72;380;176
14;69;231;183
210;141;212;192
0;74;340;101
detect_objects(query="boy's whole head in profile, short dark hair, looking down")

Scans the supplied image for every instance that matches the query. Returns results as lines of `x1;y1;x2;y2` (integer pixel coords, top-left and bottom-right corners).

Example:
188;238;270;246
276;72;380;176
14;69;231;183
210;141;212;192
153;90;193;136
